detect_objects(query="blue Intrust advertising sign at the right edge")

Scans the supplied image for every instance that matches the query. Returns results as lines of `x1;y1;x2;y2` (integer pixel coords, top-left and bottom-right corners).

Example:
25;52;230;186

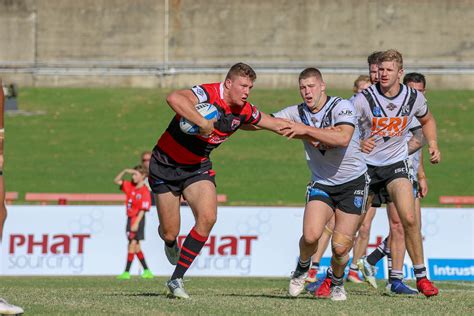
428;259;474;281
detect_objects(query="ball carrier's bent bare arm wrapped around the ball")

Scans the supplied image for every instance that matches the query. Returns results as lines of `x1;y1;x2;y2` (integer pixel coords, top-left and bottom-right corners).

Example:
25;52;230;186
166;90;216;135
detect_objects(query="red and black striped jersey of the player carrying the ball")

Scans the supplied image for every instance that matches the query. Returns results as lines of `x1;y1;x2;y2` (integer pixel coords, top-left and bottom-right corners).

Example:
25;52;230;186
157;83;261;166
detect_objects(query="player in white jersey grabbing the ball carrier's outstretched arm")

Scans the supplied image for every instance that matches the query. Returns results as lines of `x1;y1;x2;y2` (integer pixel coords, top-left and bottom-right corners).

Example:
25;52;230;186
273;68;369;300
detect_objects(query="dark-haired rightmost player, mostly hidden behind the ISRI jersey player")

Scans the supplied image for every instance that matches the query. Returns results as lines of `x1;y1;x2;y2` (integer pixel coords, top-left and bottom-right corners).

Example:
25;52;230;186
359;73;428;294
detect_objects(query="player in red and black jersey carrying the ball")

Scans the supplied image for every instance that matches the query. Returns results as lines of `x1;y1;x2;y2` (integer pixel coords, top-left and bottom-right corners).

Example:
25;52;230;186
149;63;288;298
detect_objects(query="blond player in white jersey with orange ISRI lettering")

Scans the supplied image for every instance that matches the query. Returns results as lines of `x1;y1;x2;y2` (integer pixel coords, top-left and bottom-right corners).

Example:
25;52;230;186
354;50;441;297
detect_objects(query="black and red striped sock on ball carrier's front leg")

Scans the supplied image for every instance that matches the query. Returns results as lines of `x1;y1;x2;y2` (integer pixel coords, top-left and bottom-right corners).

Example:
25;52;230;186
171;227;207;280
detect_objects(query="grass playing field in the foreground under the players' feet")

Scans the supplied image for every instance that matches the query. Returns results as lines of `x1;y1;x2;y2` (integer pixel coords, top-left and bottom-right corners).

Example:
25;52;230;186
0;277;474;315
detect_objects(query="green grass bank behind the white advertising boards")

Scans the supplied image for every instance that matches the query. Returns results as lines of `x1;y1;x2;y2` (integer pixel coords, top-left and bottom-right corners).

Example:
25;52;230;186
5;88;474;205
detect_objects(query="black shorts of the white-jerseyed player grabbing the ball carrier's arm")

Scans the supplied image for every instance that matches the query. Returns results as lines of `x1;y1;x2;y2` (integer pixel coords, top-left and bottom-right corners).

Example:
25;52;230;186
306;173;370;215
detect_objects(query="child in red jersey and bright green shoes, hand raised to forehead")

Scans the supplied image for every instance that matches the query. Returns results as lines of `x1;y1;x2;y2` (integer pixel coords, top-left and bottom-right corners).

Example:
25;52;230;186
114;165;153;280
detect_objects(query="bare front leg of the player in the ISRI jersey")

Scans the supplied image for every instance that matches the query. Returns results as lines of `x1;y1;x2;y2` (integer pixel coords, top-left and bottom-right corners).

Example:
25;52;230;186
387;178;424;265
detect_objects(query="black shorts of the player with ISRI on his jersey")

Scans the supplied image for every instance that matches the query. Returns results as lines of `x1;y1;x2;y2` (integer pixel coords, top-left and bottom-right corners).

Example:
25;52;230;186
367;160;410;202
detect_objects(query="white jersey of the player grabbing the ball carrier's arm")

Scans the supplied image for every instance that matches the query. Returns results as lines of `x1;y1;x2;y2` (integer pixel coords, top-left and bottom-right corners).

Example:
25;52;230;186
272;96;367;185
